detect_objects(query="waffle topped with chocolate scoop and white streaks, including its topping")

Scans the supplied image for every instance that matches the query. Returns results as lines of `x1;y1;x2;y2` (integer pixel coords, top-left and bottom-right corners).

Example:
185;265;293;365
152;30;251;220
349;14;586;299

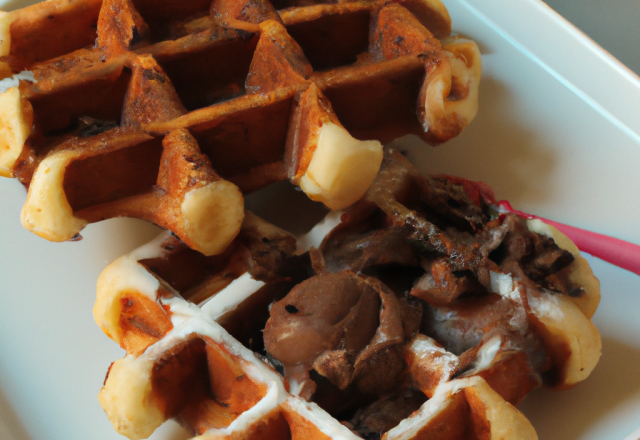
94;151;601;440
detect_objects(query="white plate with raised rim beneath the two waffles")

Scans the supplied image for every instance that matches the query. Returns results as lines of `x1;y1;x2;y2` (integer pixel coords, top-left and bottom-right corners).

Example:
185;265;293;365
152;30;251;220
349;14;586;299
0;0;640;440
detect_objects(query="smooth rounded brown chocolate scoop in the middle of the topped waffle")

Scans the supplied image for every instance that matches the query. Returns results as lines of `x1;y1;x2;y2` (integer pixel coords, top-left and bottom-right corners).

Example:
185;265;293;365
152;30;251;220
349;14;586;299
264;271;421;393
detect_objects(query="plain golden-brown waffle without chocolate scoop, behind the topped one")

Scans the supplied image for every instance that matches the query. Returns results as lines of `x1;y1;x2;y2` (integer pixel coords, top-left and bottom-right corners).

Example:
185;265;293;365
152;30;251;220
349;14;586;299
0;0;481;255
